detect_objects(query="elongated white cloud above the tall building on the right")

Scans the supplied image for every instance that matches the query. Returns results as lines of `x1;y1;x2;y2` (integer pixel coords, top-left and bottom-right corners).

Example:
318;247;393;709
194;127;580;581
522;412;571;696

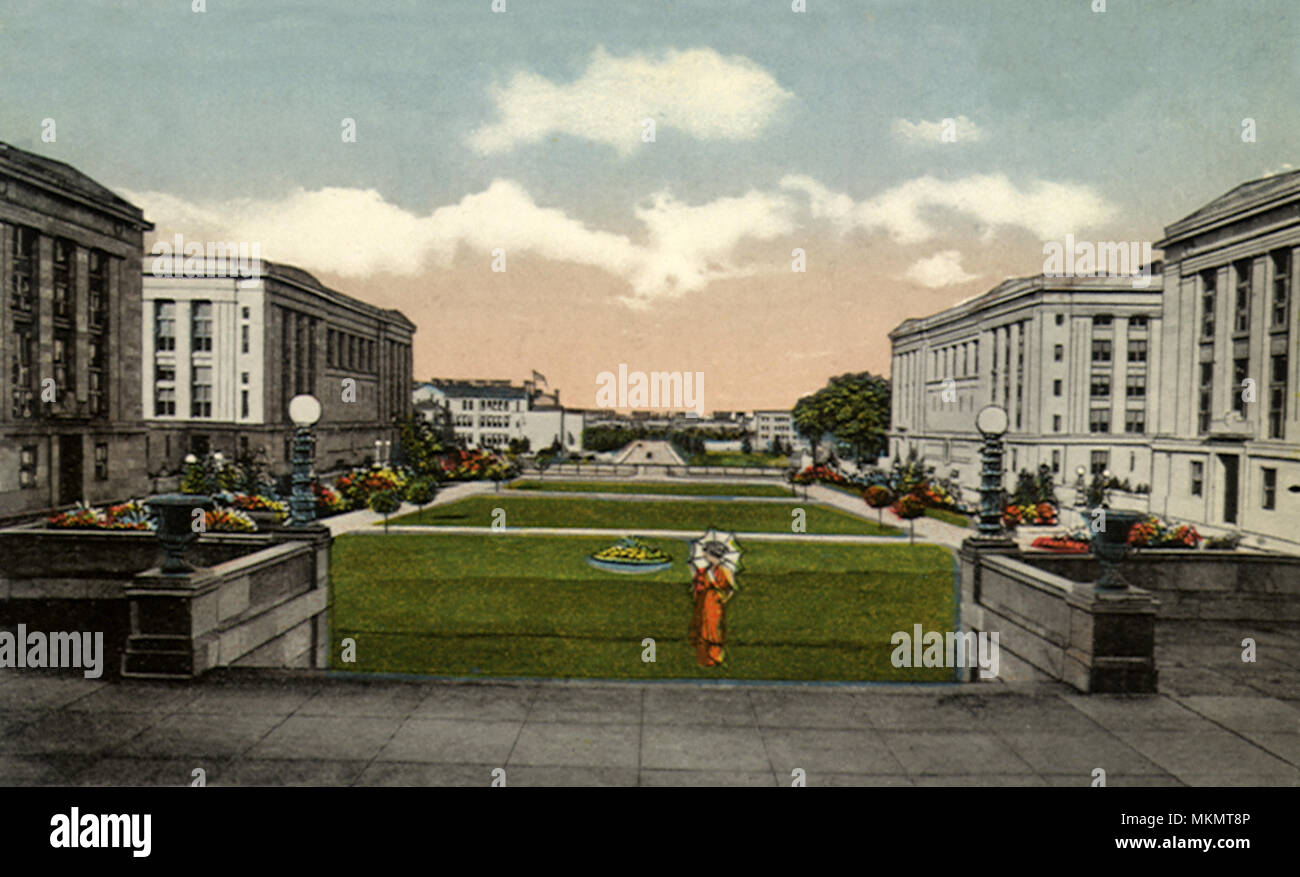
781;174;1117;244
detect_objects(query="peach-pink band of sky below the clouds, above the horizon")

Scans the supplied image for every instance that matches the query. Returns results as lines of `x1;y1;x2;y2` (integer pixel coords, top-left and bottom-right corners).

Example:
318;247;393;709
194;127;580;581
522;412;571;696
309;233;1043;412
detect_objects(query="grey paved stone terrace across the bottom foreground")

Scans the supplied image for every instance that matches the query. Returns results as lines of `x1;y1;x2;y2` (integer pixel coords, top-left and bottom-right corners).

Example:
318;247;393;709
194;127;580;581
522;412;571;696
0;670;1300;787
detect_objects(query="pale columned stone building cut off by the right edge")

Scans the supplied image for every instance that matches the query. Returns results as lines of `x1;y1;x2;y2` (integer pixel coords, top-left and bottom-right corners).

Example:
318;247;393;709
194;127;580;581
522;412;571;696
1151;172;1300;550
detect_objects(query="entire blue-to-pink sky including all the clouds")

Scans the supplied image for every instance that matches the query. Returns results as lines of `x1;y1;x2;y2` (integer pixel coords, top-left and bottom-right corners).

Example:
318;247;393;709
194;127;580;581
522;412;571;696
0;0;1300;411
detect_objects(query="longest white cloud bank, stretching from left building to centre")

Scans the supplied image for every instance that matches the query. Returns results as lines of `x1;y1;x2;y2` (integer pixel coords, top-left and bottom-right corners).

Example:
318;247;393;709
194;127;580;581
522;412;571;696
122;179;794;307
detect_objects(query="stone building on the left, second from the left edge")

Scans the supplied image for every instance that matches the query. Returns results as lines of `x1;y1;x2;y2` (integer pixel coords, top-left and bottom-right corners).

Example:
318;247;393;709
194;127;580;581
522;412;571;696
135;256;416;473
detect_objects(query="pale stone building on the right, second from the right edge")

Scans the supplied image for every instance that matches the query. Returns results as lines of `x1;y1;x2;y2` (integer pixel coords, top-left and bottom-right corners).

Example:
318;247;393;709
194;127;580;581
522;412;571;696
888;269;1161;500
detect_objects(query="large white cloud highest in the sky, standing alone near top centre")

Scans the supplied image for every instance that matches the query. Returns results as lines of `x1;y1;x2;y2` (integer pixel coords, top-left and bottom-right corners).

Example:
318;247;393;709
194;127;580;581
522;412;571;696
469;48;792;155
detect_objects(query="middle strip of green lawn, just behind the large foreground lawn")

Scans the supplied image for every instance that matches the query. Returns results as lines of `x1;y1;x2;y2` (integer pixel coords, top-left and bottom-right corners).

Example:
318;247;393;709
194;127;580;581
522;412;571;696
376;491;901;535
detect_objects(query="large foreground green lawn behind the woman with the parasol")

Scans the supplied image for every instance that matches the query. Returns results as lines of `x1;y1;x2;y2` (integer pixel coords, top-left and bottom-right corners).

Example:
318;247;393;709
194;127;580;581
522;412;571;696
330;533;956;682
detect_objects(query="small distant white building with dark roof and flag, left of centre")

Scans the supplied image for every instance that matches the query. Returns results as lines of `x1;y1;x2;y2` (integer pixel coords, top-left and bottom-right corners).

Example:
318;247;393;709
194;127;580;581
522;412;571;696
413;379;584;451
